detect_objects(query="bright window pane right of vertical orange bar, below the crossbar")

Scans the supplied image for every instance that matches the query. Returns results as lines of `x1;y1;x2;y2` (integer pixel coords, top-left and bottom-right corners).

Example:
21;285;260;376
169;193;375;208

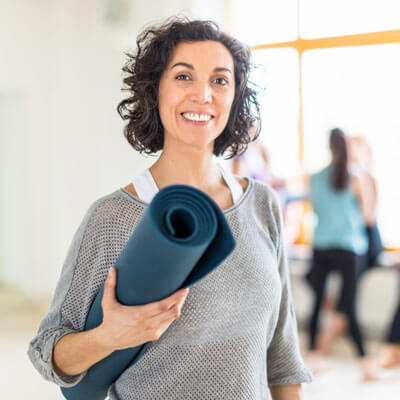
303;44;400;247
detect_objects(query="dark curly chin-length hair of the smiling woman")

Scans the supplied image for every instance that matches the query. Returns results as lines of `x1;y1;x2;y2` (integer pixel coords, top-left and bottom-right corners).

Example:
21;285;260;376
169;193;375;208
118;17;260;159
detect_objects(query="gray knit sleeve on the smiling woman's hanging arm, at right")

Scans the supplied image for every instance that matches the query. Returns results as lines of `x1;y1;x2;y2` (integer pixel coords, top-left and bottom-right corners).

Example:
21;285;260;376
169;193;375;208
267;194;312;386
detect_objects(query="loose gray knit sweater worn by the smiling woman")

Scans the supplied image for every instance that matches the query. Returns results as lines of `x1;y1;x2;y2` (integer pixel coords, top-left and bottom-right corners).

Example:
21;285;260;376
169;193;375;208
28;179;311;400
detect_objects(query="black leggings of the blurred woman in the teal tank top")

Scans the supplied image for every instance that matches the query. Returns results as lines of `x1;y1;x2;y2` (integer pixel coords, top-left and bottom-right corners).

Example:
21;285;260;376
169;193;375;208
307;249;365;356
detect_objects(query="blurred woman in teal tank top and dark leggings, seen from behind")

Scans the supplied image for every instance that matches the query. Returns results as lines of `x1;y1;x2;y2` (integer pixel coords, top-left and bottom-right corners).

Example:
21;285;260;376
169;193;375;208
308;128;375;380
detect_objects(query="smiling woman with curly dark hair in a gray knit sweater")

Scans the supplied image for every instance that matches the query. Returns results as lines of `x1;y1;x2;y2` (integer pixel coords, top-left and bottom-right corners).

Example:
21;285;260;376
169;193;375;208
29;19;310;400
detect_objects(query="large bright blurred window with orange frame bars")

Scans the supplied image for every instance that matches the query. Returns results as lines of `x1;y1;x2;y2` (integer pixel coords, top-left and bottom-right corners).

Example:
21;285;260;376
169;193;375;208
232;0;400;248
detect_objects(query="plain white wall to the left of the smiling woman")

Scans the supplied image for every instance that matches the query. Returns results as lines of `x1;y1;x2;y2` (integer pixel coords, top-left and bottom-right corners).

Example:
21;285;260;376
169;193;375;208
0;0;227;299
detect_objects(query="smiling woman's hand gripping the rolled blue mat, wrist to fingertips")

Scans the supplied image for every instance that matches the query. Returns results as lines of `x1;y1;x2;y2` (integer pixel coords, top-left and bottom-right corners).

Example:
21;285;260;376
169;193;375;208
97;267;189;351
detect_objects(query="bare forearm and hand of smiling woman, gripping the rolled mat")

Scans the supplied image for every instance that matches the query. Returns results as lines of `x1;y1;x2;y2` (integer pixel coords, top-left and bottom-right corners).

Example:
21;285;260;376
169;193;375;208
53;267;188;376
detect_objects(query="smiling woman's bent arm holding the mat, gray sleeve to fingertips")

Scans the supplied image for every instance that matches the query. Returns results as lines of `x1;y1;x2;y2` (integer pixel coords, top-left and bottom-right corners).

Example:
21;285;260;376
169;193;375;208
28;203;186;387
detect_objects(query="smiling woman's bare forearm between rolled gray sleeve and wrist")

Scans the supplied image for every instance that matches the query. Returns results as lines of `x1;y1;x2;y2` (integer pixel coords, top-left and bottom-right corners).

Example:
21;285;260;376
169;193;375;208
53;328;113;376
